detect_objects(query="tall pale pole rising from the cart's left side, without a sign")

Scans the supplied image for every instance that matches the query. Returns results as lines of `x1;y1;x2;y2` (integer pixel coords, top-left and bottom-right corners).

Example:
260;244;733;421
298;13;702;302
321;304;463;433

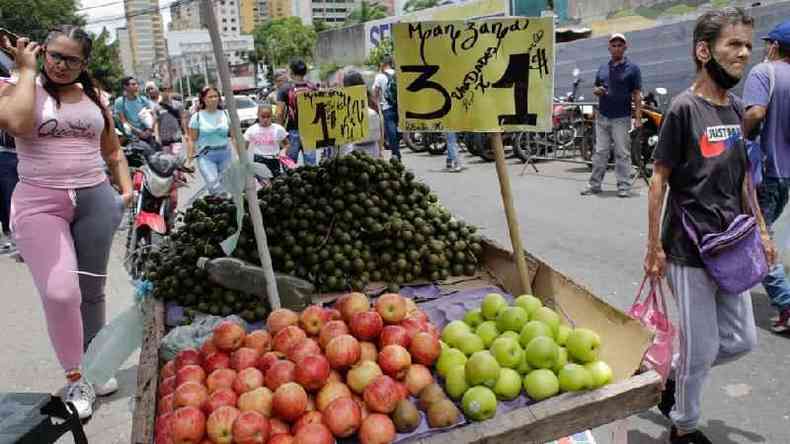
202;0;281;310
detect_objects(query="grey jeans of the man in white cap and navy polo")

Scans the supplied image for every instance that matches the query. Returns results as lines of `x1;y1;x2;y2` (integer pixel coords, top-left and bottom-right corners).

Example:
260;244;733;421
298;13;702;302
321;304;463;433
590;116;631;191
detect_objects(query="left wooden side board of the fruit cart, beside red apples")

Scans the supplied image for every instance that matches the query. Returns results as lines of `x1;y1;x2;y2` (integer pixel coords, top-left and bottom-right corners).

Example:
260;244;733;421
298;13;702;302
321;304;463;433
131;297;165;444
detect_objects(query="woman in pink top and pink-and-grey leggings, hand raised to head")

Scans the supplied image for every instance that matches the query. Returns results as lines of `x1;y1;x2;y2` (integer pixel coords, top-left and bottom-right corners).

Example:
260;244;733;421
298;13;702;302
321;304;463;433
0;26;132;418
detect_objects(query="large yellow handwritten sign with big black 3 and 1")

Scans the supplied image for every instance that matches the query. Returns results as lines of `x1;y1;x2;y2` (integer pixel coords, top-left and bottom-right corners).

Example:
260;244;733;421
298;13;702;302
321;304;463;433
393;17;554;132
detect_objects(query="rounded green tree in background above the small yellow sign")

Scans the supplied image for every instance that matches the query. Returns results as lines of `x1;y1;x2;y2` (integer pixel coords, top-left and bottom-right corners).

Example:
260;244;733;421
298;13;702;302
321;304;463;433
253;17;317;67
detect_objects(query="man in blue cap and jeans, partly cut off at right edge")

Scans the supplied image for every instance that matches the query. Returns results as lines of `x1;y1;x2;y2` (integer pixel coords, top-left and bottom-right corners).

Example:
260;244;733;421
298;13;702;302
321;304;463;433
743;20;790;333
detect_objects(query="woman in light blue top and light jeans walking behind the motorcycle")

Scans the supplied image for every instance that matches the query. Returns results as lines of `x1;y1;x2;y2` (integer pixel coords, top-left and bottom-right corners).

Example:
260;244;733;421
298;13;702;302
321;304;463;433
187;86;231;195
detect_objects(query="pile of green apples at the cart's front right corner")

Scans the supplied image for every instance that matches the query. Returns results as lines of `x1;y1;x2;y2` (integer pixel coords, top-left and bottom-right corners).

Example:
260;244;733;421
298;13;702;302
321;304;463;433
436;293;612;421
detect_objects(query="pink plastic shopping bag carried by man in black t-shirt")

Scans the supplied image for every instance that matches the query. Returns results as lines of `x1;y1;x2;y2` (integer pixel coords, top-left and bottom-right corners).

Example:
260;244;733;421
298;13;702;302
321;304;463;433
628;276;676;382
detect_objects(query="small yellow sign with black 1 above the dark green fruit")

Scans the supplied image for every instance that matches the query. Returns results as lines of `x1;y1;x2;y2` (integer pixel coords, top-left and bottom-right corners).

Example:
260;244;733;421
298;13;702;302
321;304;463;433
297;85;368;150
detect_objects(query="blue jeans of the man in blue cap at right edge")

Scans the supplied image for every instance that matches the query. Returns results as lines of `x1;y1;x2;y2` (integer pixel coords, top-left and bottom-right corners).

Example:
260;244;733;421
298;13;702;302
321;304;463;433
757;177;790;311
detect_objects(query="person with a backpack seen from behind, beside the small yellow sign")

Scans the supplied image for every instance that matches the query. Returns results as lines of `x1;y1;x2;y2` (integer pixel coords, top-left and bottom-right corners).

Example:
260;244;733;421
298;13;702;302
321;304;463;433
277;60;318;165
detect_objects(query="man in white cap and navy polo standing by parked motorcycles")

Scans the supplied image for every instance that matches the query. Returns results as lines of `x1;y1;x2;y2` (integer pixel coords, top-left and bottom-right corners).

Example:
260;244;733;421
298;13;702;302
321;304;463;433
581;33;642;197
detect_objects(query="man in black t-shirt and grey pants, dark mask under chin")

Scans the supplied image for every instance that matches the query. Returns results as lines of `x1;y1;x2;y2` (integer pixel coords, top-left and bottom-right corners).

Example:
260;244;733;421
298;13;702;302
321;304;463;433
645;8;776;444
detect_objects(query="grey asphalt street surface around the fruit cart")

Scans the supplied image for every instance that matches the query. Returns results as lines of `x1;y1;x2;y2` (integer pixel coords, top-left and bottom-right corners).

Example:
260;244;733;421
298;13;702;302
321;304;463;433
0;150;790;444
